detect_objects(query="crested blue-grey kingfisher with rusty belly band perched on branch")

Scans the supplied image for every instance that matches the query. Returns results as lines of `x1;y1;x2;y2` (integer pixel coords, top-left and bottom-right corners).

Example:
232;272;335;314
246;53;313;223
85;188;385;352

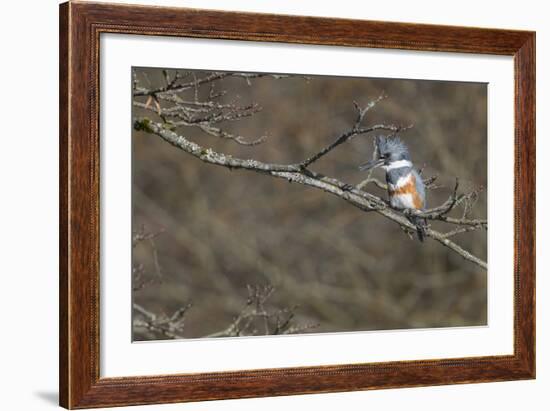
359;136;426;241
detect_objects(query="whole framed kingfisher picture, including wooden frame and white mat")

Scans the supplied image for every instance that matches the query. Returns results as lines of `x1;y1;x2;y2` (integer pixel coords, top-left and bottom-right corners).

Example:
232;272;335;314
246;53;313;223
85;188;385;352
60;2;535;408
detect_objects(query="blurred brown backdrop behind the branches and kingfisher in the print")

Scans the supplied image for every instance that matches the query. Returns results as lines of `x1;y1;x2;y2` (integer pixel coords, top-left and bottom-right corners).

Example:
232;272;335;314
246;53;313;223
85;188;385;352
132;68;487;340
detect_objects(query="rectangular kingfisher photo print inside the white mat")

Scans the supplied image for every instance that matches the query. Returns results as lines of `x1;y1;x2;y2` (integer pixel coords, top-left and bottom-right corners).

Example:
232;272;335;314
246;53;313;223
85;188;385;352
132;67;488;341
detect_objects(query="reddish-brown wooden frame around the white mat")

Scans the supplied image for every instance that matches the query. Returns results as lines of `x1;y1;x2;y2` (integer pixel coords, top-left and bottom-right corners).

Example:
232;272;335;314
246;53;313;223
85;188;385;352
59;2;535;409
